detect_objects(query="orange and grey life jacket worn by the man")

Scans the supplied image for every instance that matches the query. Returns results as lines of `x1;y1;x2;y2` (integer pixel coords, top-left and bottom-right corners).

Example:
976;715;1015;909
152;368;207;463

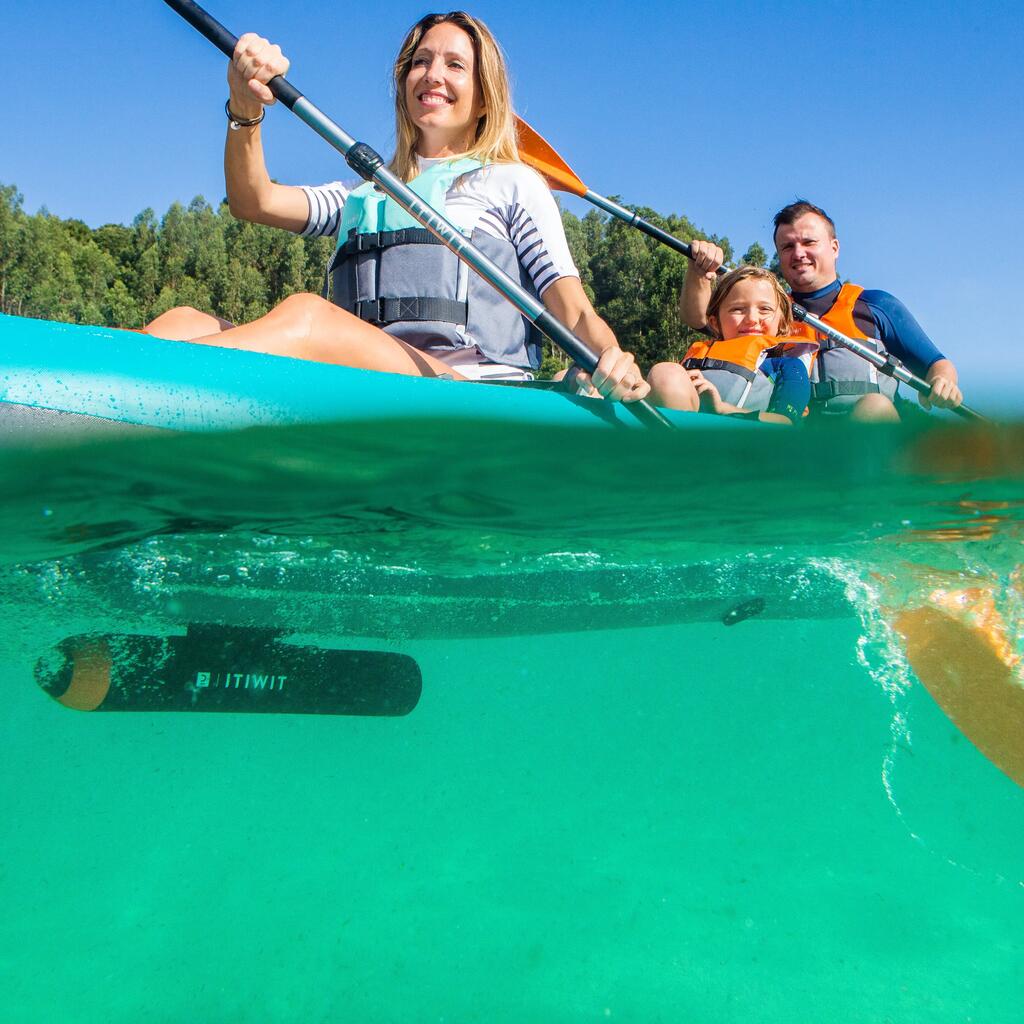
793;285;898;413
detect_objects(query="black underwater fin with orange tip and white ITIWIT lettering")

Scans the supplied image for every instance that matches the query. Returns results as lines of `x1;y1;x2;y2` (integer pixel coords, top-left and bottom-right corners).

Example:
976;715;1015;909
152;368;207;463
36;625;422;717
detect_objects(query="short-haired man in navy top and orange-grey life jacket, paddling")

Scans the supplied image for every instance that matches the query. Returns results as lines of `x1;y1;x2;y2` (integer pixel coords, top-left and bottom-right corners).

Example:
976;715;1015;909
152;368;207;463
680;200;963;421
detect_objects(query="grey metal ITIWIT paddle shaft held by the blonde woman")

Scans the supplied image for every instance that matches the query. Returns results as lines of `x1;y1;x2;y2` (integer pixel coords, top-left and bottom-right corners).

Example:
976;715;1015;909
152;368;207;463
164;0;673;428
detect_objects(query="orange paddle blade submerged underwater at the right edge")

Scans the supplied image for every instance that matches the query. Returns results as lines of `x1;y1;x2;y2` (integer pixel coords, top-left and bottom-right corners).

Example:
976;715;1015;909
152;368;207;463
895;607;1024;786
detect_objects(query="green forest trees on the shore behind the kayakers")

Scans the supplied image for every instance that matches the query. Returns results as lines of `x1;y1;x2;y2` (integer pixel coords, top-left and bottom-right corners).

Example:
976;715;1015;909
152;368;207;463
0;184;766;373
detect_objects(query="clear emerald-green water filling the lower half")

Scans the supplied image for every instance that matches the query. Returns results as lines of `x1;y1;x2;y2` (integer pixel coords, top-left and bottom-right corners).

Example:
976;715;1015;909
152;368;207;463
0;413;1024;1024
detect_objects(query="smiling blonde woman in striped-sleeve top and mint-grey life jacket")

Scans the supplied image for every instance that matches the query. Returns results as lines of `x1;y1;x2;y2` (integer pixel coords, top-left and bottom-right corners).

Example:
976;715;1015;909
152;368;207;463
146;11;649;401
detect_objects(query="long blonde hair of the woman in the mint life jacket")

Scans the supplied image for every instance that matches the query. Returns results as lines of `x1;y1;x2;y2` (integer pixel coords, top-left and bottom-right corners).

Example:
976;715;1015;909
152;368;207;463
390;10;519;181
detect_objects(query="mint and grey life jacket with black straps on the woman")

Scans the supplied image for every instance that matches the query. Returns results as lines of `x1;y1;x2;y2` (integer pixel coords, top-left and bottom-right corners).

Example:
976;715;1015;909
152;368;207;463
328;159;542;370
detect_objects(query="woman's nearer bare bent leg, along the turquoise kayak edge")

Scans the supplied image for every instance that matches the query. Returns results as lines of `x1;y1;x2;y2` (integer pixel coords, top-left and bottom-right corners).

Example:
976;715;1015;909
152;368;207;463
160;294;465;380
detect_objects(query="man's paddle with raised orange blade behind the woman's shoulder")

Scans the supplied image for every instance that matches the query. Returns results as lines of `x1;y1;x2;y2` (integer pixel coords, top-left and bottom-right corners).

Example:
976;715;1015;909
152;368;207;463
516;118;987;422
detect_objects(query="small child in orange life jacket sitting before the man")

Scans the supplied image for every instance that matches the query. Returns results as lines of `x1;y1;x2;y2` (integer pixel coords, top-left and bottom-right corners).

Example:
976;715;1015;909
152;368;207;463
648;263;816;423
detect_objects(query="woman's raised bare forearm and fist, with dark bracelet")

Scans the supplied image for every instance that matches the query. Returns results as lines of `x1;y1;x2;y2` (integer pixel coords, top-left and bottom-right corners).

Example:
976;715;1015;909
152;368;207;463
224;32;309;232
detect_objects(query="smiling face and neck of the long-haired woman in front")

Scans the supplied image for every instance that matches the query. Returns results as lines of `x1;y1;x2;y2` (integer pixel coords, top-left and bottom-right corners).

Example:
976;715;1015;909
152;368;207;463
406;22;484;157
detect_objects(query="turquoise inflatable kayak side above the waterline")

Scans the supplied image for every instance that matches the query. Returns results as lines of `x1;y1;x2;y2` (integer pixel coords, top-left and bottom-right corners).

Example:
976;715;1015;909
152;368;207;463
0;315;750;443
